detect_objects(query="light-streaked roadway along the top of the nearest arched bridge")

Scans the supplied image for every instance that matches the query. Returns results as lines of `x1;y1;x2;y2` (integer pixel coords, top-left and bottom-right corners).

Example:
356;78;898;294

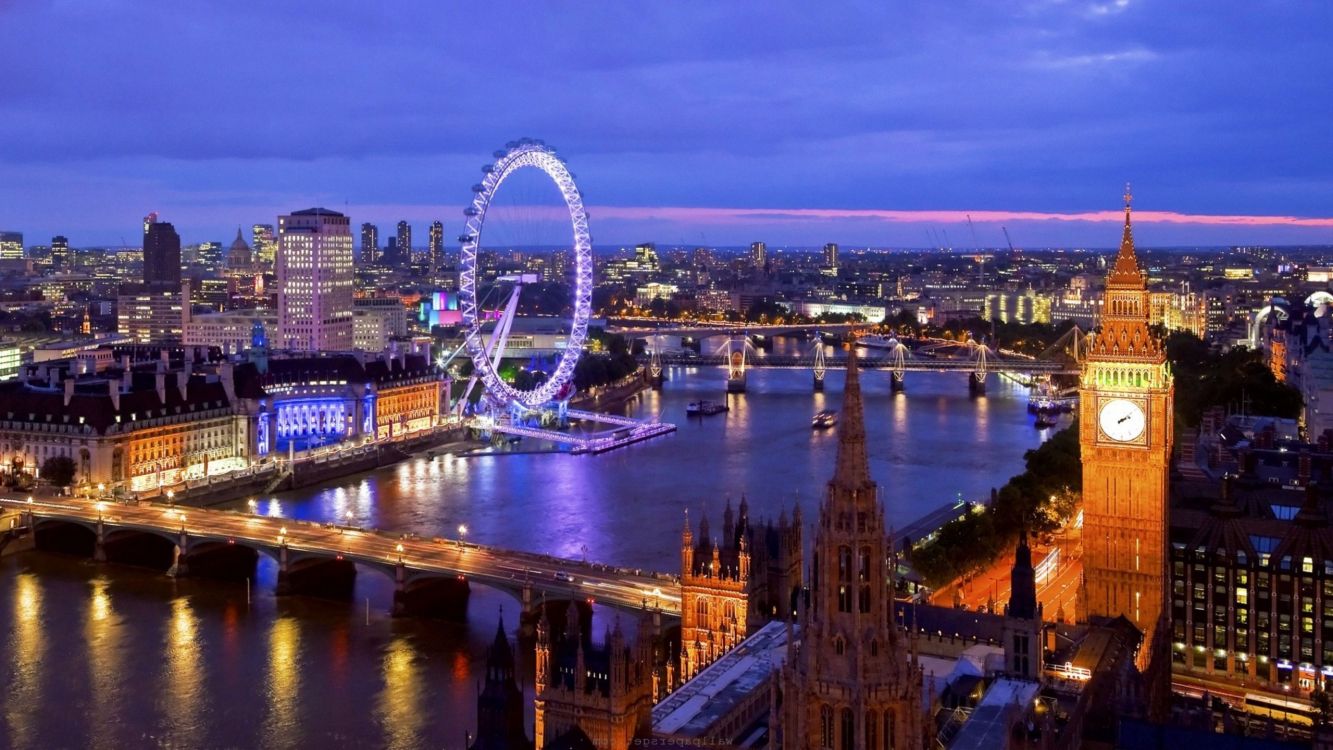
0;497;680;615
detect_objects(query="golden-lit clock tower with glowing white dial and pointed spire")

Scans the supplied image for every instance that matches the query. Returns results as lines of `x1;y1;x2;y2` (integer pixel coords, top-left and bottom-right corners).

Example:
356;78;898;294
1078;187;1174;669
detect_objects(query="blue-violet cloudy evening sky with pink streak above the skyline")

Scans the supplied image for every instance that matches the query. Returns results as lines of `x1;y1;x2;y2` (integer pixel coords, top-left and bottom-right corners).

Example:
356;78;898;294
0;0;1333;248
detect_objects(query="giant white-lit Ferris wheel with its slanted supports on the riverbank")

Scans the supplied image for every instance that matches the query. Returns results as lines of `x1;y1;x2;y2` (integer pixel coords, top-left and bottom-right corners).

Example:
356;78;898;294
459;139;592;410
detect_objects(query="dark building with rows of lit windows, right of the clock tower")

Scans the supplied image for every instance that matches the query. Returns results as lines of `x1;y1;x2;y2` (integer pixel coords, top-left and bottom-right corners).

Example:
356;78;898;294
1170;474;1333;695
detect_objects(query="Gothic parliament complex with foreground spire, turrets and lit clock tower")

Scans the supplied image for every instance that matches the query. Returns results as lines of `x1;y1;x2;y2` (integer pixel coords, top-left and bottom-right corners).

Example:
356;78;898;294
471;192;1173;750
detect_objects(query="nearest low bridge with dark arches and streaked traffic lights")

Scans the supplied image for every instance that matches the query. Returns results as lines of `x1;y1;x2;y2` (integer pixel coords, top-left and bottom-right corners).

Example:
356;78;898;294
0;497;680;618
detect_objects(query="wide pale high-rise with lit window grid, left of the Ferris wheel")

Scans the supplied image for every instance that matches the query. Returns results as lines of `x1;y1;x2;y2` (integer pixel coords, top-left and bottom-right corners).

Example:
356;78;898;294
277;208;353;352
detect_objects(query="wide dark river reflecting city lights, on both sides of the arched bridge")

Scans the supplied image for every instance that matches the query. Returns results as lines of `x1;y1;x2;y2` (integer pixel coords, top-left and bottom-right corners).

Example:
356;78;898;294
0;359;1049;749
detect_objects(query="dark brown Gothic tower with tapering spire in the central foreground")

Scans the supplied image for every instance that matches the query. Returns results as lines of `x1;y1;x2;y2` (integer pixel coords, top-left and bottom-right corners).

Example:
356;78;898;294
769;348;934;749
